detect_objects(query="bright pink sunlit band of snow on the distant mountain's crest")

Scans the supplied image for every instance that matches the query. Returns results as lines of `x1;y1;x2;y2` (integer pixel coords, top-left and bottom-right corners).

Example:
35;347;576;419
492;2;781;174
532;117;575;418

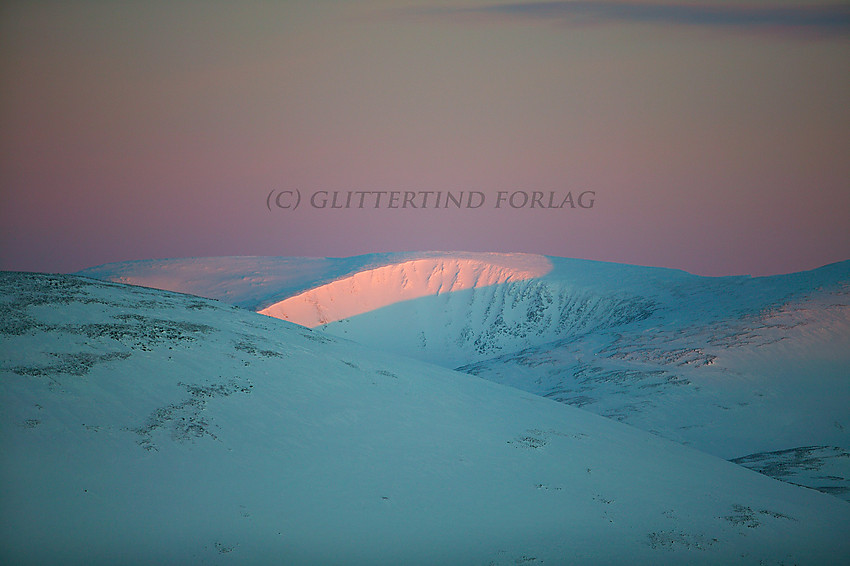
259;253;552;328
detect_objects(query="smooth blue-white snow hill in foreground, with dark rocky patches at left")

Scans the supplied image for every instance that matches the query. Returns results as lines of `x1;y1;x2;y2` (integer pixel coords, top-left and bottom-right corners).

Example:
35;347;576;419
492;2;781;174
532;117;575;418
0;273;850;565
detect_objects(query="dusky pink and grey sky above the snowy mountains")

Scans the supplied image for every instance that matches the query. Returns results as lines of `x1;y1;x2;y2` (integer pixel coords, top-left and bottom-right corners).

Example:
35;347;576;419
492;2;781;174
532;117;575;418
0;0;850;275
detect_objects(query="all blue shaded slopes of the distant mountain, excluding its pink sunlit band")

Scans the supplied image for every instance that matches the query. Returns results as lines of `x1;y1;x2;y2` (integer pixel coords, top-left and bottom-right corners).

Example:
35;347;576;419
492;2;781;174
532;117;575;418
255;258;850;500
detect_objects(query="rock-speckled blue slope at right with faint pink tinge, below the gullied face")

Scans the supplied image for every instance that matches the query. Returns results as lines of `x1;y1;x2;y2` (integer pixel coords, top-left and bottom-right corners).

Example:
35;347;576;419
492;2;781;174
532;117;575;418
461;266;850;499
